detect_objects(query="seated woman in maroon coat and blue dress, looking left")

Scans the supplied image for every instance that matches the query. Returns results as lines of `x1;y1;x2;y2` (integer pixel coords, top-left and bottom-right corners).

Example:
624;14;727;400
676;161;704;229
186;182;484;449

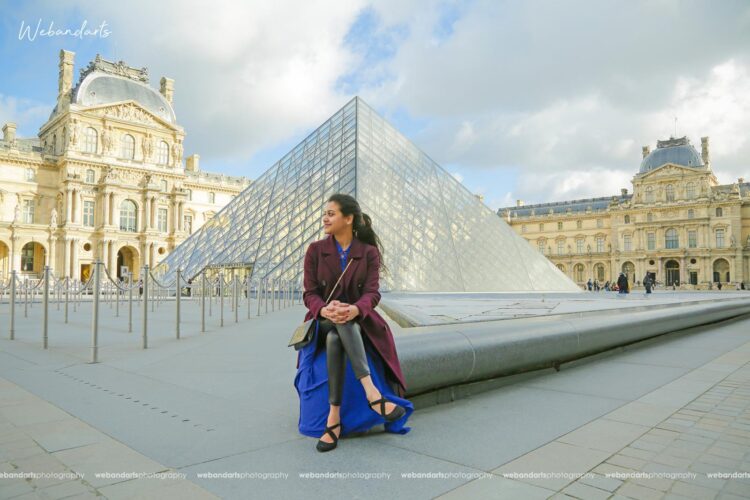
294;194;414;451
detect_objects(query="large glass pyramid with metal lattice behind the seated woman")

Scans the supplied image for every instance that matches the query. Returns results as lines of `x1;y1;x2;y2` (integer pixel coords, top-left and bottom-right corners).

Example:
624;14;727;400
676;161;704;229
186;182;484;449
154;97;580;292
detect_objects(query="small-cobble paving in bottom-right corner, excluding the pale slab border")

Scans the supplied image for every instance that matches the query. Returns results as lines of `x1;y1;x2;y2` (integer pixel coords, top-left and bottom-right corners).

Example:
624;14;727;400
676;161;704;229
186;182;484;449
552;356;750;500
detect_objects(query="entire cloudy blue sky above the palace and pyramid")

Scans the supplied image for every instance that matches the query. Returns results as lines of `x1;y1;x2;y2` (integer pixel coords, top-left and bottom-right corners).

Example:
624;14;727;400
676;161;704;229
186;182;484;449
0;0;750;210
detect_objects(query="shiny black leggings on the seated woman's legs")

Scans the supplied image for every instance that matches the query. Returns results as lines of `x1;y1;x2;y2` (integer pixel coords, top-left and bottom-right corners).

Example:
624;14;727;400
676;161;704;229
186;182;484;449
317;319;370;406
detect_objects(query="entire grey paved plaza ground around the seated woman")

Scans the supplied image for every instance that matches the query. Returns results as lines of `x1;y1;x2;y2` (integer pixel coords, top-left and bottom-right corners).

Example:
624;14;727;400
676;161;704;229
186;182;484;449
0;292;750;499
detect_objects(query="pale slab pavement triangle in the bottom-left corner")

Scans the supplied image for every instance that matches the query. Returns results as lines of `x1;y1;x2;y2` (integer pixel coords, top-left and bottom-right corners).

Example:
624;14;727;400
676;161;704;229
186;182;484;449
0;378;218;500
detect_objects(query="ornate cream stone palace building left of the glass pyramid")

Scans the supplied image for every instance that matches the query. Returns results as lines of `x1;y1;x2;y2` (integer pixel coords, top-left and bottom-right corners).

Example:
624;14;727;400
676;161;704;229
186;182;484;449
0;50;250;280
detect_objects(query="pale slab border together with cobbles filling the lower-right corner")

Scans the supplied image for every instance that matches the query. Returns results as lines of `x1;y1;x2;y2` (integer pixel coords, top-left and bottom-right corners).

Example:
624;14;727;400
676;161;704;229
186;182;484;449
439;332;750;500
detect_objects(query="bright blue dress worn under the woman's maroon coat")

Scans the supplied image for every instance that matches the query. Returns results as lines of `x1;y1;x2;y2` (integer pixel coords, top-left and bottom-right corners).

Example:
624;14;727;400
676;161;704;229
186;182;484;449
294;238;414;438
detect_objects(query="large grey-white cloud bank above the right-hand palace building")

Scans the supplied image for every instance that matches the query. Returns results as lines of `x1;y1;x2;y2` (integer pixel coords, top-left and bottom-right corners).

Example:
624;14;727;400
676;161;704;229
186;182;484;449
360;0;750;204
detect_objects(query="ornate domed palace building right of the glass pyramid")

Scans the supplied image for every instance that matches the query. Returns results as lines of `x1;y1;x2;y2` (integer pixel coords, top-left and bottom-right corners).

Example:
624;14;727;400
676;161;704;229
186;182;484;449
498;137;750;289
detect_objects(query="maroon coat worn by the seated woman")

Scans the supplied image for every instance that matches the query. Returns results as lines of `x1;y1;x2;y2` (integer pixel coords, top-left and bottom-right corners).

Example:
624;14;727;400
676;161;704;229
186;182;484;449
297;234;406;397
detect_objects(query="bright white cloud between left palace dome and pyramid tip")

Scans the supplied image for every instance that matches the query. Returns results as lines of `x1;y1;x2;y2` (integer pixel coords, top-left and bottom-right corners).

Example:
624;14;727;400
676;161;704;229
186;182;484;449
20;0;374;175
